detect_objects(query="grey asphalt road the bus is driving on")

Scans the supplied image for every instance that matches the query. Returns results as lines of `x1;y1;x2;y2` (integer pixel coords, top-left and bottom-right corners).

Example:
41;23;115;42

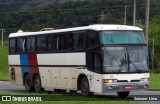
0;81;160;104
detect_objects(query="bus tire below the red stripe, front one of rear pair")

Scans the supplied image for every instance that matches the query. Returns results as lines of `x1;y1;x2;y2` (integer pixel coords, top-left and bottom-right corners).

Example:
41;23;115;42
33;74;44;92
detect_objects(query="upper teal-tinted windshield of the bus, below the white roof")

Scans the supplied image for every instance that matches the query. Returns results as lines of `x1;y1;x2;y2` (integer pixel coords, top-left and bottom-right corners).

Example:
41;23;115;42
100;30;145;44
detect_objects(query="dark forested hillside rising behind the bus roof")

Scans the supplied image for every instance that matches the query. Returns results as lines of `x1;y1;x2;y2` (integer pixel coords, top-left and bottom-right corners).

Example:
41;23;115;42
0;0;160;37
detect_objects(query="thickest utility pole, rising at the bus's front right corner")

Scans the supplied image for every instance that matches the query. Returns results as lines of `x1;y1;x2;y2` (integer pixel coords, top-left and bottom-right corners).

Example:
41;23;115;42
145;0;150;45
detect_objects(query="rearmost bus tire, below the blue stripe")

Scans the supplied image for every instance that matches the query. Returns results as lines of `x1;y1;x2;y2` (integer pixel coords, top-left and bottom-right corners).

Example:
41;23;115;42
24;74;34;92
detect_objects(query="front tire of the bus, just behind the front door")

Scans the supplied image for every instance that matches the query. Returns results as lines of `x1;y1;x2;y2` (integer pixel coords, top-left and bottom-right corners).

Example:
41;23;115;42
80;77;90;96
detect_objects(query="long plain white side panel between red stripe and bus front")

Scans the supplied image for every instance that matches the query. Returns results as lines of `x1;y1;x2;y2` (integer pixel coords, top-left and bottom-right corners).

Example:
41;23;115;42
37;52;86;66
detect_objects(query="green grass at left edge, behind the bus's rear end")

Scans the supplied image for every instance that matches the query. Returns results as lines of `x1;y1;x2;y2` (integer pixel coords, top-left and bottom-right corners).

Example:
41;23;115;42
0;47;9;80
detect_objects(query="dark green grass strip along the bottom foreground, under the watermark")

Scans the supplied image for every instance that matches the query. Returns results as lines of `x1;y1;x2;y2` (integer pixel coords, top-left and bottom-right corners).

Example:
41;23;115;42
0;92;142;104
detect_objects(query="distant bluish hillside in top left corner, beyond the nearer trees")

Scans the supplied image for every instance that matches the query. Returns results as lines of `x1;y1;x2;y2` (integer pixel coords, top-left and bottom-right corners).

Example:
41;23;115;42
0;0;84;12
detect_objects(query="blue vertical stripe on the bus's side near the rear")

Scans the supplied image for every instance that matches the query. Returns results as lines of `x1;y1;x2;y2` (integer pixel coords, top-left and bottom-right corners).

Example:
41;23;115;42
20;54;30;76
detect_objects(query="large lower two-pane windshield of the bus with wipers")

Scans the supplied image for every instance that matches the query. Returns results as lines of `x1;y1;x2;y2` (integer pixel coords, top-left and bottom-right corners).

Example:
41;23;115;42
102;46;148;73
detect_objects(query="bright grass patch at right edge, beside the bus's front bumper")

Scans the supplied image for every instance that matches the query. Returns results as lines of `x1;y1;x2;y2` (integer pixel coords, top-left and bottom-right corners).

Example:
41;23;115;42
149;74;160;90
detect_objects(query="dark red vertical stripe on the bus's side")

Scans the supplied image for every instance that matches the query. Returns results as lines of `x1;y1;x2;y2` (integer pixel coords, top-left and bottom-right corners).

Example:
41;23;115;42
28;54;39;79
